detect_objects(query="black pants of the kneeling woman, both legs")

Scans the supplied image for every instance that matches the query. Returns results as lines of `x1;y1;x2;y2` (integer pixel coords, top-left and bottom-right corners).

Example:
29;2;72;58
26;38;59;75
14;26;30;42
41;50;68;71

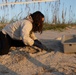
0;31;26;55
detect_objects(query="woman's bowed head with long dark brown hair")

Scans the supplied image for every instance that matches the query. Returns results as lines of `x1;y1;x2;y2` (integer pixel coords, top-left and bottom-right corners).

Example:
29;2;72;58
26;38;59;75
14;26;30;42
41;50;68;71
31;11;44;33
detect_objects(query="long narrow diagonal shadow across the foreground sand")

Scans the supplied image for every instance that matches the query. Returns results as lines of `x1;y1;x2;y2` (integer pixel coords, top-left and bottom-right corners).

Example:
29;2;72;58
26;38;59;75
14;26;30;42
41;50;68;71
13;51;66;75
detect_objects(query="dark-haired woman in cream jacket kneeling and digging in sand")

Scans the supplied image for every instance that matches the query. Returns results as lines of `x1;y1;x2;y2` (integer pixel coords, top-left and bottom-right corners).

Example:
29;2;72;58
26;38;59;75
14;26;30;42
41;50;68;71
0;11;46;55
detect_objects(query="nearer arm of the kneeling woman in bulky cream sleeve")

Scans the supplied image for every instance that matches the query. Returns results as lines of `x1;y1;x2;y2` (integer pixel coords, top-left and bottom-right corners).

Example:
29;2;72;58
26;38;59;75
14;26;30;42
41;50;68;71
21;21;34;46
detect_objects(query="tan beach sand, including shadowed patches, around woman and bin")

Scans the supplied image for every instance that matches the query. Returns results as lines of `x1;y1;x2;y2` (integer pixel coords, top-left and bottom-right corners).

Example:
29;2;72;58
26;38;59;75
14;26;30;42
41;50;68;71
0;28;76;75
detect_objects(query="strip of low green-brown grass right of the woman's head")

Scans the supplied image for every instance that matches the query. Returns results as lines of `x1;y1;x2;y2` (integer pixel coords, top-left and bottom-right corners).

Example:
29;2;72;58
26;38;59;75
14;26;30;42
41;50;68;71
43;23;76;31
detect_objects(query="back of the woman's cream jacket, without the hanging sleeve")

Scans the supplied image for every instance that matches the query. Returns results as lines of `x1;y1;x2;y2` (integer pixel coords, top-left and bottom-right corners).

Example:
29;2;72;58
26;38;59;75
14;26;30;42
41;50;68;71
2;19;31;40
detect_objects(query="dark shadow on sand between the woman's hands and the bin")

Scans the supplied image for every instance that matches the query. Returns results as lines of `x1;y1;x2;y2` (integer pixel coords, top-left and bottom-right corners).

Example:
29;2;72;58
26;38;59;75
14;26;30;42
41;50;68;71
40;39;64;52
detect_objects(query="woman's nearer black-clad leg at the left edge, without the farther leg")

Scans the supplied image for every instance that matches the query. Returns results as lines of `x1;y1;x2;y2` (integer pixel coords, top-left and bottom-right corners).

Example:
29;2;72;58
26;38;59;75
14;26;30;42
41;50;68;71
0;32;11;55
